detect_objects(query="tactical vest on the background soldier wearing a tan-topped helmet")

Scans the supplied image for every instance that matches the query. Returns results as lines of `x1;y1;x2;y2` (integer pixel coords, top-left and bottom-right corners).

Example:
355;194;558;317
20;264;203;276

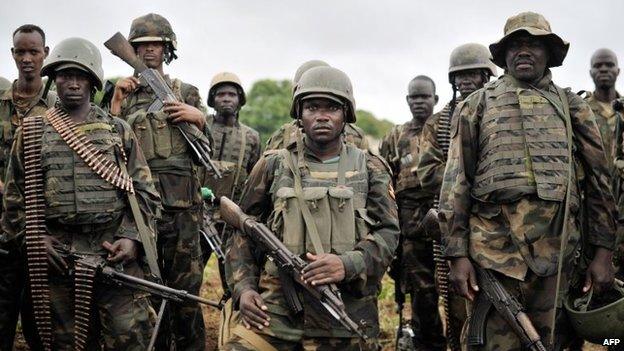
204;116;253;201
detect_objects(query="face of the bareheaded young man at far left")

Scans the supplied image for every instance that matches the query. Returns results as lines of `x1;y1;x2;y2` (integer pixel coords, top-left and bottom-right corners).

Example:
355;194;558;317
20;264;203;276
11;31;49;80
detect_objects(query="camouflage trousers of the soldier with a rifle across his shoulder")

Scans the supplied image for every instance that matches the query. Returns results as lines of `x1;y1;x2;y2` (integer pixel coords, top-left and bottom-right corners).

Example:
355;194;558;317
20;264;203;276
153;208;206;350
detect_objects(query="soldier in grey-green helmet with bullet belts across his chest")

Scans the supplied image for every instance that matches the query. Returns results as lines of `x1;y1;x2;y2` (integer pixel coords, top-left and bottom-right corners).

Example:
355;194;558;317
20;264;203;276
2;38;159;350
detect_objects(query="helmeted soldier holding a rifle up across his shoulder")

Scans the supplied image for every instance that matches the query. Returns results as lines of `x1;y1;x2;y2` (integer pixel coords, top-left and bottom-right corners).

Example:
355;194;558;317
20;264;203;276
111;13;208;350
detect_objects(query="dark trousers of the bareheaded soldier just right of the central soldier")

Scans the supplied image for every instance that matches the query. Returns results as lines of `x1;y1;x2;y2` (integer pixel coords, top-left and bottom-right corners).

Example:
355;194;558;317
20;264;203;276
399;204;446;351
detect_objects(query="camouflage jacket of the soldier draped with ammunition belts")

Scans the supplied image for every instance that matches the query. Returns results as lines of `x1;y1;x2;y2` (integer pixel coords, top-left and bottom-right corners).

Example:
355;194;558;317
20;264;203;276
2;105;160;255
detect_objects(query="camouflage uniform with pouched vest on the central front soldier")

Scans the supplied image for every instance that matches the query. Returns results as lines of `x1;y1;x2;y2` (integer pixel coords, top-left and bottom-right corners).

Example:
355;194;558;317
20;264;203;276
225;140;398;350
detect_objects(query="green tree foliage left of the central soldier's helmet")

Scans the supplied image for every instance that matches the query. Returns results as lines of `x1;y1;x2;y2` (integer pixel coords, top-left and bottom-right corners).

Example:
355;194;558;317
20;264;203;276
240;79;292;145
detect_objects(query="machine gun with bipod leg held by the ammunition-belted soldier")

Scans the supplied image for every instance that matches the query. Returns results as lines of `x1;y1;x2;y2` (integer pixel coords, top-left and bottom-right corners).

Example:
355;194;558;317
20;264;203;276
55;247;223;351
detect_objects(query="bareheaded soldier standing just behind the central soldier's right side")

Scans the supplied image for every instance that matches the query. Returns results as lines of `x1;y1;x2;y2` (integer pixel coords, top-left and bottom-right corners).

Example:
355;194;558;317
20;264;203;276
379;76;445;350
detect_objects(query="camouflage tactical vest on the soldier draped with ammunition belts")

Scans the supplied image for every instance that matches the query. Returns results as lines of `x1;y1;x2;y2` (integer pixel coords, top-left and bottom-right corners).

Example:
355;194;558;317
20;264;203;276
41;108;126;224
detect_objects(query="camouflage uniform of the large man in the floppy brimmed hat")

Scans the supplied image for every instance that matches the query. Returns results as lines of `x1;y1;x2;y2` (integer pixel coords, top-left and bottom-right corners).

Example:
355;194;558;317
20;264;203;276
440;70;615;350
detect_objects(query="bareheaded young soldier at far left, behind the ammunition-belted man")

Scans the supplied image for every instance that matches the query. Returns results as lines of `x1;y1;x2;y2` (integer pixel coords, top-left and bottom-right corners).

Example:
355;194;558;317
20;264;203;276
0;24;56;350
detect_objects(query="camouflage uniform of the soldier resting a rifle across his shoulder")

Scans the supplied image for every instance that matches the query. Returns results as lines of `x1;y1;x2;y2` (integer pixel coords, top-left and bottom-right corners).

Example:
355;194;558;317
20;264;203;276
119;76;208;350
